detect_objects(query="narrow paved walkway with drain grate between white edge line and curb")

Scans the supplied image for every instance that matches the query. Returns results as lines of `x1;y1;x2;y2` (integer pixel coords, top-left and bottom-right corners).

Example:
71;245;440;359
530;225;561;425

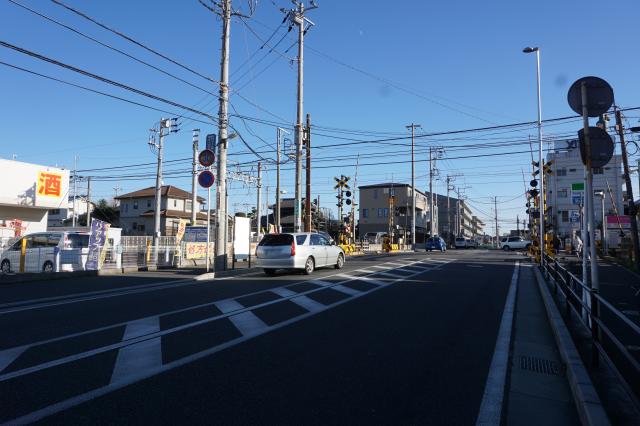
505;264;580;425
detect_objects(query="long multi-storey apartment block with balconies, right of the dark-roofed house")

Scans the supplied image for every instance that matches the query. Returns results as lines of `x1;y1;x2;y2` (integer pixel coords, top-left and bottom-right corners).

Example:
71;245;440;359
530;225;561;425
435;194;485;244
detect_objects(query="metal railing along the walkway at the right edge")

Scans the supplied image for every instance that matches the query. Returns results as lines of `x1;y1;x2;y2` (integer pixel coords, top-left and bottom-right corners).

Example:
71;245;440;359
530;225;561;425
543;255;640;402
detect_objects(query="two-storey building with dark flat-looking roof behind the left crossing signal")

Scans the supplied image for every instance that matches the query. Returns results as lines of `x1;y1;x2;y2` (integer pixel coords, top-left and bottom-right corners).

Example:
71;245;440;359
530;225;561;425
358;183;437;242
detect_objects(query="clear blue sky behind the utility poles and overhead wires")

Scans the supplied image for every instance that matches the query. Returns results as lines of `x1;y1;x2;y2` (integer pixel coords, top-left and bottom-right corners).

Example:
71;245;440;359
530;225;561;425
0;0;640;233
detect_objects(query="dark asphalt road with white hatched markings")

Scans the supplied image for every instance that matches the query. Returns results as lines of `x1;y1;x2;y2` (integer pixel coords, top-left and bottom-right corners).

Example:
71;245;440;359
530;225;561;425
0;250;519;424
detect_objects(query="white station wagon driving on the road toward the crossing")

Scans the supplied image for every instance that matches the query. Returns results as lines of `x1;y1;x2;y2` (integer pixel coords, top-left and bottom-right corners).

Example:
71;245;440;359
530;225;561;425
256;232;345;275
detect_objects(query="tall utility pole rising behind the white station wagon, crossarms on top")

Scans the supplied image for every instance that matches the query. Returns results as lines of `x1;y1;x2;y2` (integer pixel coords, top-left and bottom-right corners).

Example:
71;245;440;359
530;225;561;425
288;0;317;232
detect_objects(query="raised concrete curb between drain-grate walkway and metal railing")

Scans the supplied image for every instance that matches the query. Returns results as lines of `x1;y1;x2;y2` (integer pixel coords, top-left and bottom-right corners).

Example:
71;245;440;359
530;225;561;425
533;267;611;425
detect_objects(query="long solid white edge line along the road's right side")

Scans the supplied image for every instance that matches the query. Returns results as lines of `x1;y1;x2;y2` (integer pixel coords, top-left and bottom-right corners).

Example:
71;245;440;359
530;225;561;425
476;261;520;426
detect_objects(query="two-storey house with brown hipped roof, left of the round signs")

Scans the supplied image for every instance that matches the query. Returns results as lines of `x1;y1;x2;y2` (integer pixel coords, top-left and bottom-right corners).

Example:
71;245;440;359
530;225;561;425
115;185;206;236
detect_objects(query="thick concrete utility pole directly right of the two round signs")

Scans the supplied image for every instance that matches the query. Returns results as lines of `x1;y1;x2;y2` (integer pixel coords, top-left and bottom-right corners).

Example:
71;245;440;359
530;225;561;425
215;0;231;271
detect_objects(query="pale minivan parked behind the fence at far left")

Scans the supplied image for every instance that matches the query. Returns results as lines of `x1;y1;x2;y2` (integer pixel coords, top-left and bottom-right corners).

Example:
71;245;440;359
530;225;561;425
0;231;89;273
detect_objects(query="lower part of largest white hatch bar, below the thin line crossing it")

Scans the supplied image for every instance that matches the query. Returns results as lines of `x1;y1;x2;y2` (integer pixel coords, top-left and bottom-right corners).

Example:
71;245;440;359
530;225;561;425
110;337;162;383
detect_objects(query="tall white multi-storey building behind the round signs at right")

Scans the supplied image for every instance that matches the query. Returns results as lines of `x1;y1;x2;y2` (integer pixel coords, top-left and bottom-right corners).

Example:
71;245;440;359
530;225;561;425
545;139;624;238
